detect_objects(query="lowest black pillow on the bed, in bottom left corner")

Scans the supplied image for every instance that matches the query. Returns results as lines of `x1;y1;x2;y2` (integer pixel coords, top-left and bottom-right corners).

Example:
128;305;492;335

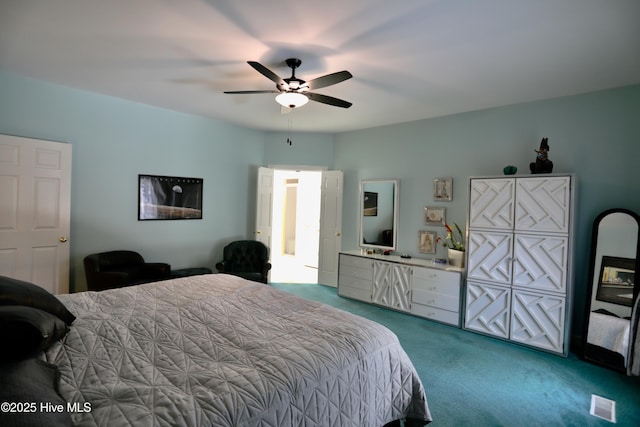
0;358;71;427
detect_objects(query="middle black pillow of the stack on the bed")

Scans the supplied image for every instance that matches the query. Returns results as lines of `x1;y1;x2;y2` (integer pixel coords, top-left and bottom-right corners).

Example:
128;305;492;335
0;305;69;361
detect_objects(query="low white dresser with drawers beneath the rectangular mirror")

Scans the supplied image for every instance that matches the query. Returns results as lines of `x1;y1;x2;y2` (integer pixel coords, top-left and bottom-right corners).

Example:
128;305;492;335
338;251;463;327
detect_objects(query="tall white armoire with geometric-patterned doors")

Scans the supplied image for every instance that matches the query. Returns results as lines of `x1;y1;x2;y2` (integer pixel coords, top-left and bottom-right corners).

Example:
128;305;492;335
464;174;575;355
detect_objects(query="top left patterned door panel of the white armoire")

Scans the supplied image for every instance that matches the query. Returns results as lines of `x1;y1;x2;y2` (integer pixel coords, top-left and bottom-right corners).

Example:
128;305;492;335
469;179;515;230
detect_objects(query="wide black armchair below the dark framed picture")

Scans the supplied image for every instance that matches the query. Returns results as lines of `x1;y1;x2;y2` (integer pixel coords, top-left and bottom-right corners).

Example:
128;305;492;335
84;251;171;291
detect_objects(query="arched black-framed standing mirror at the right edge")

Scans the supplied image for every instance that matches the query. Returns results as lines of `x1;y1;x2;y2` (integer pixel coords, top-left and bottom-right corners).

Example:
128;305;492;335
583;209;640;375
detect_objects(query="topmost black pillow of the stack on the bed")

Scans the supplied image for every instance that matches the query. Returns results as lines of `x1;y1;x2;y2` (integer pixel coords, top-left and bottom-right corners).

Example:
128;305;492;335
0;276;76;325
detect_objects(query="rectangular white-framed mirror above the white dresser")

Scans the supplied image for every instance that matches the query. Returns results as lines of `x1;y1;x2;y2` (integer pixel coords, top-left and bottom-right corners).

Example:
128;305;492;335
360;180;398;250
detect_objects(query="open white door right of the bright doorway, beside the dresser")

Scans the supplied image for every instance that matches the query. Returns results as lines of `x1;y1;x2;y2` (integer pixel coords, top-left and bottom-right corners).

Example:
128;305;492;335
318;171;343;287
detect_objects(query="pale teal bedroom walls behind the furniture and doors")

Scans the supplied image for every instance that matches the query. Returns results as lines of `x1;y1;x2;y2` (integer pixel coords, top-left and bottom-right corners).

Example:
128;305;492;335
0;68;640;340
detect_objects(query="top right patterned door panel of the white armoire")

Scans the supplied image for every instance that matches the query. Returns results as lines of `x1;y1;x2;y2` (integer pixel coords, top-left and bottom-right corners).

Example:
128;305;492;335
515;176;571;233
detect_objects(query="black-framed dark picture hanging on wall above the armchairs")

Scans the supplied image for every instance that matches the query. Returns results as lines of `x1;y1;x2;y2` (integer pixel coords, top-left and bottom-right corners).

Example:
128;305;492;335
138;175;203;221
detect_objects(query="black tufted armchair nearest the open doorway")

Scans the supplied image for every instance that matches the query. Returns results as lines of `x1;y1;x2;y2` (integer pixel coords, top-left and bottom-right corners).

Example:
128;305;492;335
216;240;271;283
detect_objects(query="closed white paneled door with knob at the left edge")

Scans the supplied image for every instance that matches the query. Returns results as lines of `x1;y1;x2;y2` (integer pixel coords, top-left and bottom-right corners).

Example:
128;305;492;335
0;135;71;294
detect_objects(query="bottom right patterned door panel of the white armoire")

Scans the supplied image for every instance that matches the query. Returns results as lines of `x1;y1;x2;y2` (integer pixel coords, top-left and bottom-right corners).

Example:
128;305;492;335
511;290;565;352
